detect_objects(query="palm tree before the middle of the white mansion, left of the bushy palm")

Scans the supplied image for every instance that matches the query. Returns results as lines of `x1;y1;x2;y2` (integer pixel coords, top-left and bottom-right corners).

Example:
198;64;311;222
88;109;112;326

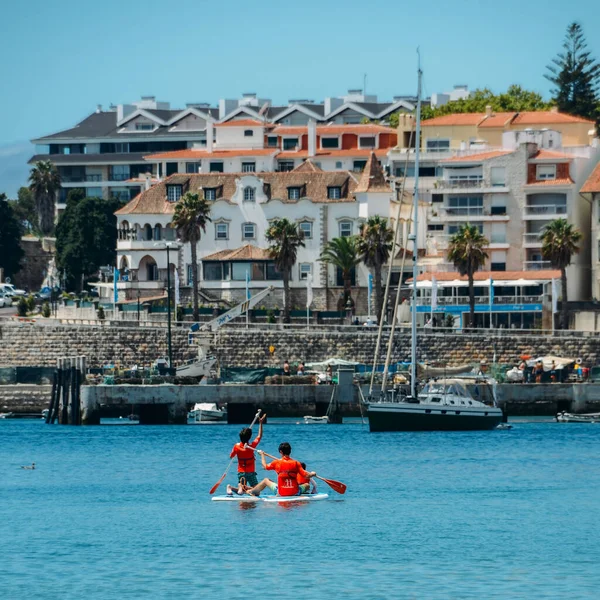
265;219;304;323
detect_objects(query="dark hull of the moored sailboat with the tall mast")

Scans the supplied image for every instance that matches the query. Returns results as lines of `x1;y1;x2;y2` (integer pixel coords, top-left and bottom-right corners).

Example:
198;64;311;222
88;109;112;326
367;402;502;431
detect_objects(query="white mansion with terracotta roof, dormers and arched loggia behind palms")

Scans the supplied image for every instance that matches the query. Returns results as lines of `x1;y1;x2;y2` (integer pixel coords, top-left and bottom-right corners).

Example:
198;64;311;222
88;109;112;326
116;153;426;310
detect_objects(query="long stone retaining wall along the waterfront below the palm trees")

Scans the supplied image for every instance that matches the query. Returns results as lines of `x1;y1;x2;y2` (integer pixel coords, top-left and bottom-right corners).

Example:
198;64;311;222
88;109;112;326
0;323;600;367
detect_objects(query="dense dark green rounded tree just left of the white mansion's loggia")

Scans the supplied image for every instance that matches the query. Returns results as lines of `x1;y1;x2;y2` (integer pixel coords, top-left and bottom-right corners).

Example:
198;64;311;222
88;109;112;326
56;194;121;290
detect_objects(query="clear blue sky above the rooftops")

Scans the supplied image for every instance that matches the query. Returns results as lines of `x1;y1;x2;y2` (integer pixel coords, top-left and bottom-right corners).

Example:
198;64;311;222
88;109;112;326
0;0;600;145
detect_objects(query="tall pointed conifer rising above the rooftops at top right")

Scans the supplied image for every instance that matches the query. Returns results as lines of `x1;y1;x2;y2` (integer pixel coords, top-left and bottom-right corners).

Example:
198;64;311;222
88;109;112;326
544;23;600;119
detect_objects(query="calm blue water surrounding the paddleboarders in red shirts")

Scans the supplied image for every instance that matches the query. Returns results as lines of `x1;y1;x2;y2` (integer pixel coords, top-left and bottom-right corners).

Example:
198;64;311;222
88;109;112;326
0;421;600;600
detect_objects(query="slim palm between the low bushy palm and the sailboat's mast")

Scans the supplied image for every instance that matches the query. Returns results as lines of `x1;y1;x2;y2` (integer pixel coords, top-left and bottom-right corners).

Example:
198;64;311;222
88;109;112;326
356;215;394;323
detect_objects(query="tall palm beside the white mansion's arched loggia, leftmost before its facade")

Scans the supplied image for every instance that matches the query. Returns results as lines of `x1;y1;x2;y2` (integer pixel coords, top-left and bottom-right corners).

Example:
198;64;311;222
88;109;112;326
167;192;211;321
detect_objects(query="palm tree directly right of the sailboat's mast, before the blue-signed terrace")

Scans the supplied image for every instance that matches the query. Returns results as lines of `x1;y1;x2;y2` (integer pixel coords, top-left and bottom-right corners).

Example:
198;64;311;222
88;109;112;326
448;223;489;327
